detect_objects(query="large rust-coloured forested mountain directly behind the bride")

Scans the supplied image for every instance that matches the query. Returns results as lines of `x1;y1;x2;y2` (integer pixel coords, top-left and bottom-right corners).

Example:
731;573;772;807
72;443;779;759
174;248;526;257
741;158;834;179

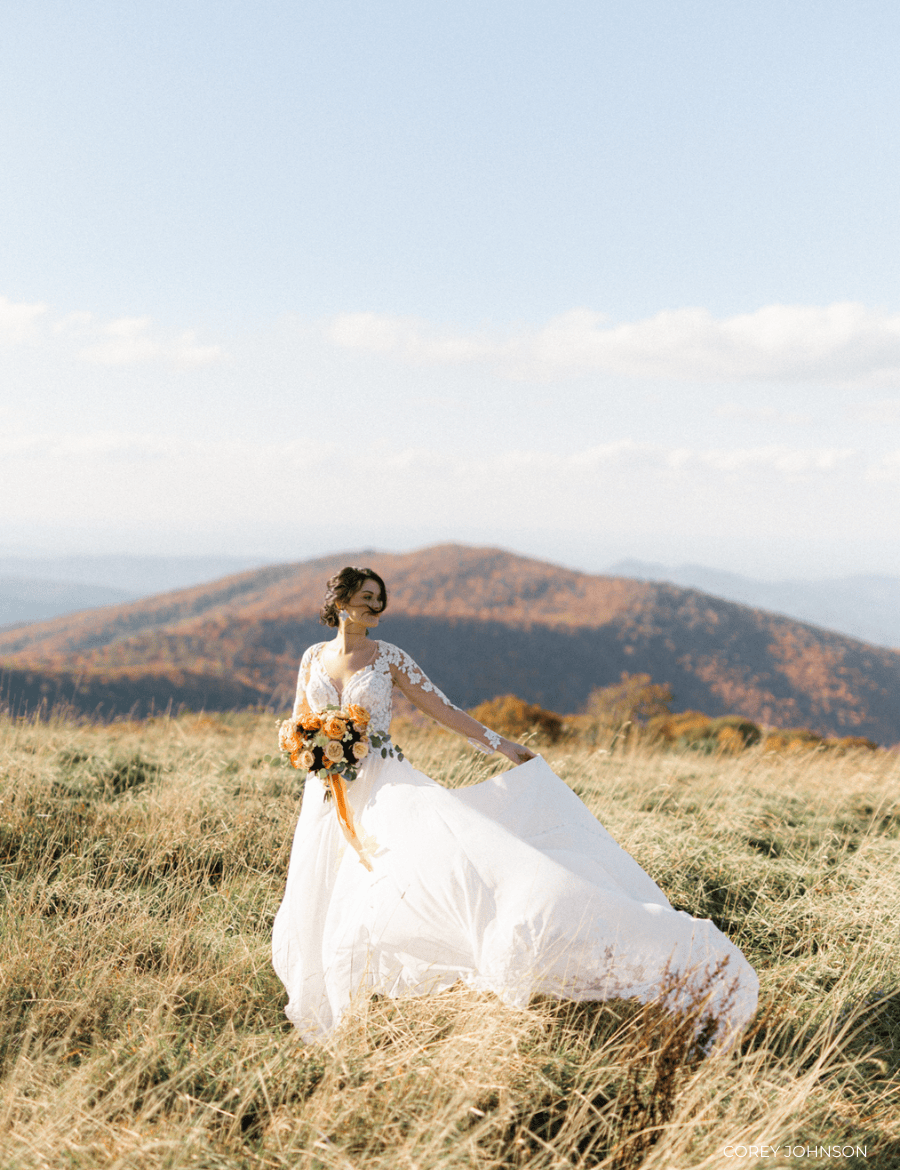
0;545;900;744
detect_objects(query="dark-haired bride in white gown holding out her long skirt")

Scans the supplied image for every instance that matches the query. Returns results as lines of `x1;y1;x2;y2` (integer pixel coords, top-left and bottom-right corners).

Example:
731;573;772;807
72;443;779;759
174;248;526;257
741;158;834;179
273;567;758;1044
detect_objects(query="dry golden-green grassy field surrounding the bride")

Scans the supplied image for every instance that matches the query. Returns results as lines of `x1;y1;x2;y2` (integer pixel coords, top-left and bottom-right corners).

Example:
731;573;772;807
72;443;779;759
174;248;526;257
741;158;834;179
0;715;900;1170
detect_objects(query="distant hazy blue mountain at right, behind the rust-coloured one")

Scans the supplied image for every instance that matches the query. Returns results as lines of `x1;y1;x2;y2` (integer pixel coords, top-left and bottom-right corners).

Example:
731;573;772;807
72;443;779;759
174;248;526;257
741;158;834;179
607;560;900;648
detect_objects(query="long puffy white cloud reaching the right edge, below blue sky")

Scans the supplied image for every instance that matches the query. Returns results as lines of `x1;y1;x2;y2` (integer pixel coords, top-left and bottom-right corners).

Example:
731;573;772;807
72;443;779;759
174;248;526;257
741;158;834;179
328;303;900;385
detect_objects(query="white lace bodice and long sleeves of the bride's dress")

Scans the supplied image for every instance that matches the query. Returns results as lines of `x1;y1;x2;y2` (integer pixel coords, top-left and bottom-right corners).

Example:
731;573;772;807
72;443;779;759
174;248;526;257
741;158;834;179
294;641;501;755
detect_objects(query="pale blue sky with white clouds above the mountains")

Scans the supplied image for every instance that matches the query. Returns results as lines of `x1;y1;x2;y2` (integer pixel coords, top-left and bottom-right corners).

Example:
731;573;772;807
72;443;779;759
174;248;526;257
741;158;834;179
0;0;900;579
